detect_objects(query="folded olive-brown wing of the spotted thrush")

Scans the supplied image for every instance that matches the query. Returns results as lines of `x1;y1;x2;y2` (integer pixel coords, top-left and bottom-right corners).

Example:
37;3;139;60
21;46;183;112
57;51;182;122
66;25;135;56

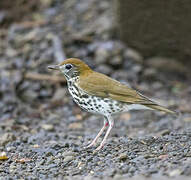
78;72;156;104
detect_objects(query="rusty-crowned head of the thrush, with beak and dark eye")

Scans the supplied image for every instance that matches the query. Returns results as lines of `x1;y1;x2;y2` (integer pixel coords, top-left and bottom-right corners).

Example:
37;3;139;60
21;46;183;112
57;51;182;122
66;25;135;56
48;58;92;80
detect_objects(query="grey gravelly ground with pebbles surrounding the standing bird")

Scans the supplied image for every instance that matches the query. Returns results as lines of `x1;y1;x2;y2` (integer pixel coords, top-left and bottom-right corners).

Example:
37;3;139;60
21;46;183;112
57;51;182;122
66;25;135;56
0;0;191;180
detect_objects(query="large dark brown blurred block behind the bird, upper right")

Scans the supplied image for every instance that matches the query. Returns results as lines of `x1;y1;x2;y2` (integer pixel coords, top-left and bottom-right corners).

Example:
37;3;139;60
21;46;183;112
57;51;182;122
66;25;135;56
114;0;191;60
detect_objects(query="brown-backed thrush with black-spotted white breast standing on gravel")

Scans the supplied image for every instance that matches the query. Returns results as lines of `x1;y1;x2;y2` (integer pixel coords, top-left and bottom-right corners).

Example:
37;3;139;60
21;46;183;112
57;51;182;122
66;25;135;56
48;58;176;151
